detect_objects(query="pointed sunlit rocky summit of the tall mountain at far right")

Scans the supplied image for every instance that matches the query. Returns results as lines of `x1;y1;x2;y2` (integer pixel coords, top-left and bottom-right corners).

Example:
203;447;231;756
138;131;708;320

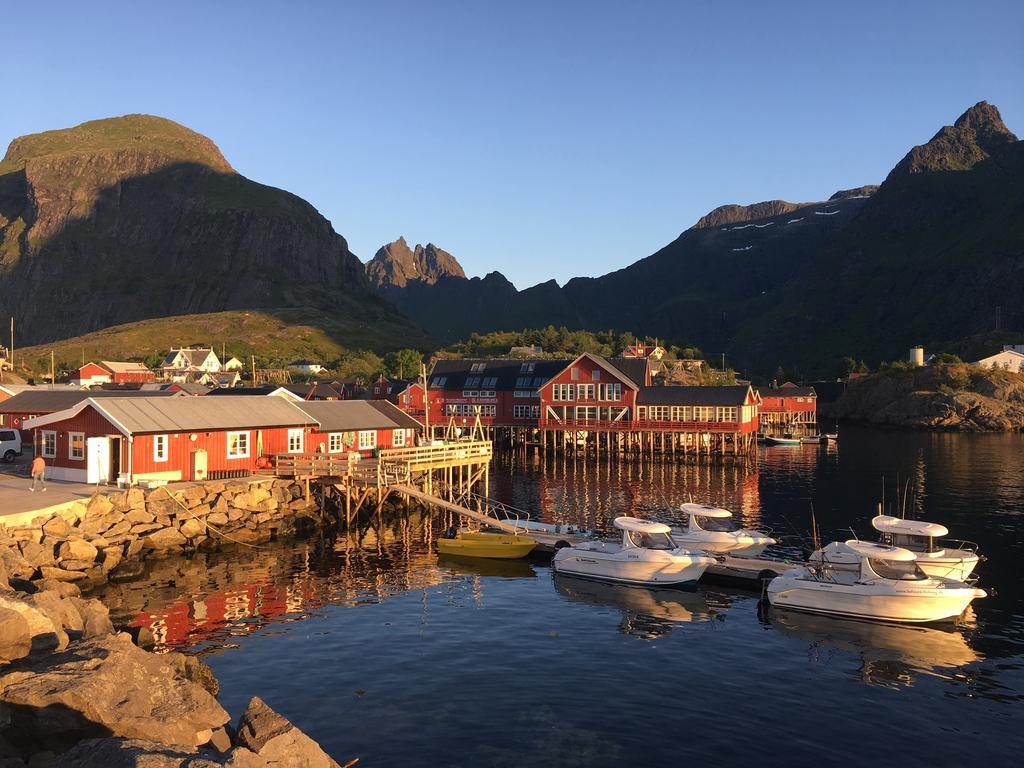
889;101;1017;178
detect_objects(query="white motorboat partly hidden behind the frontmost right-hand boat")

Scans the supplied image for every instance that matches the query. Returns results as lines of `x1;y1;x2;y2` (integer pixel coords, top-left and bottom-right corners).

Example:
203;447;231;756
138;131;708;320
811;515;981;582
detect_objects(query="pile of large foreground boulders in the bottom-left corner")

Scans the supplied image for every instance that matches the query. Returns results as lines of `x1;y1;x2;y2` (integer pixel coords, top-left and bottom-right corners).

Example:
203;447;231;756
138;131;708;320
0;573;348;768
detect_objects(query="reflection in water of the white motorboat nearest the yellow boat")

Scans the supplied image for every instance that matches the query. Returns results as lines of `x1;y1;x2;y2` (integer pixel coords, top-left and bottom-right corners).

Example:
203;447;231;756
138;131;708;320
554;574;729;640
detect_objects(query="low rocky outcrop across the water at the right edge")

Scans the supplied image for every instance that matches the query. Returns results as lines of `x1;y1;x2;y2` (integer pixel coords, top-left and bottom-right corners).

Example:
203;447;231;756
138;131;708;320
821;364;1024;432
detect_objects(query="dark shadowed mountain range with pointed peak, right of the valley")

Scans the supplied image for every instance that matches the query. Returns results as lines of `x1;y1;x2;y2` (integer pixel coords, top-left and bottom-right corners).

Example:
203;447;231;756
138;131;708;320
370;101;1024;376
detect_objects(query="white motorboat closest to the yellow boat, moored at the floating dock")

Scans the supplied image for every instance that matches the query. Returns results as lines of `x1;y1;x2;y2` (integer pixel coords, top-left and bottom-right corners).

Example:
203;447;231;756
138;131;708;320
551;517;715;587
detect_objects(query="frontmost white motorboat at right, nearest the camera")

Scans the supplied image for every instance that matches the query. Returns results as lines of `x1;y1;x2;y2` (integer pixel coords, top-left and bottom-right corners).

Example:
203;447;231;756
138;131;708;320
767;540;986;624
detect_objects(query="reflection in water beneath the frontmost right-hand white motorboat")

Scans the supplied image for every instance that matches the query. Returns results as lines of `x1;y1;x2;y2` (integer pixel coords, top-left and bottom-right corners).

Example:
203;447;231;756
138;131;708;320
766;608;983;687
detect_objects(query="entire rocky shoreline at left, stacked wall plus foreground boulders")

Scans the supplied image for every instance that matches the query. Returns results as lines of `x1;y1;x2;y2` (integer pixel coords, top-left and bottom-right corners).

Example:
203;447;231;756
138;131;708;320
0;479;348;768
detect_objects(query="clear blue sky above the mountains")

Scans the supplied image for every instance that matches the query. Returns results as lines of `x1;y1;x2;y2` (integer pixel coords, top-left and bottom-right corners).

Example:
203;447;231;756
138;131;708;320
0;0;1024;288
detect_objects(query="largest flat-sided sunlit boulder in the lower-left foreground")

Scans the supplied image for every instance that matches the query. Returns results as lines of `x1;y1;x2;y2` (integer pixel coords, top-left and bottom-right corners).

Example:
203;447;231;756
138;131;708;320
0;633;228;749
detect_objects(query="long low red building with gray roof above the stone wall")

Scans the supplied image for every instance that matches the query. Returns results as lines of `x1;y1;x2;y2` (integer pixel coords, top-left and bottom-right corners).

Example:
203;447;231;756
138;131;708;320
23;395;423;483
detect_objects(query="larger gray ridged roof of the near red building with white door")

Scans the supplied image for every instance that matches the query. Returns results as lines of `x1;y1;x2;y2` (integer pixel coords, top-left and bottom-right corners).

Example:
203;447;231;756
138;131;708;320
92;395;315;434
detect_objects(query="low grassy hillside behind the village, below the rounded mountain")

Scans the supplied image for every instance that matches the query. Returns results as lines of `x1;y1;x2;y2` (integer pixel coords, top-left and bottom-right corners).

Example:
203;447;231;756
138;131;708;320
15;306;432;375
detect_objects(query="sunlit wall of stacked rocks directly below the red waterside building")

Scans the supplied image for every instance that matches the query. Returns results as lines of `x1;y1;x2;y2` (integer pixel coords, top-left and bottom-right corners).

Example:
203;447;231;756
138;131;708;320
0;478;318;596
